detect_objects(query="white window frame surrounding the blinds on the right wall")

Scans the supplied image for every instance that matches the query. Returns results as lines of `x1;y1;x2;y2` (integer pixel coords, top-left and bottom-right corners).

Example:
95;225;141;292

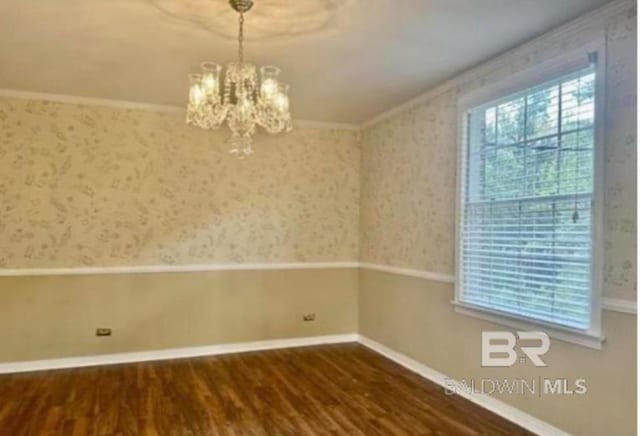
452;39;606;349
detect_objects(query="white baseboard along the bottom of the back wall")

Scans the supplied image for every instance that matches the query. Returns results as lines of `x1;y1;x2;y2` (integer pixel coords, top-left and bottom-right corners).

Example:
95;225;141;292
0;333;358;374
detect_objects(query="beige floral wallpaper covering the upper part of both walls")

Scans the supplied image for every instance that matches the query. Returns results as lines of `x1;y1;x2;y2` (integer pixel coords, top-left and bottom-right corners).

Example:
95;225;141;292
0;2;637;299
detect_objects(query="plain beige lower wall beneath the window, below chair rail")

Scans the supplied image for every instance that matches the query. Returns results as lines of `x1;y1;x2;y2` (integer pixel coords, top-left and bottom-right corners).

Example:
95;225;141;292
359;270;636;436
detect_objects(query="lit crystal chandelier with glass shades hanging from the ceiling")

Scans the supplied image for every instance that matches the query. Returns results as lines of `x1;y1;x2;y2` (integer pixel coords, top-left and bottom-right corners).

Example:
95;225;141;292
187;0;292;158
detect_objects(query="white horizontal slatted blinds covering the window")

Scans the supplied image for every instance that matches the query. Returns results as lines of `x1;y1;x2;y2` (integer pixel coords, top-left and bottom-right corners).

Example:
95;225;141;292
459;66;595;330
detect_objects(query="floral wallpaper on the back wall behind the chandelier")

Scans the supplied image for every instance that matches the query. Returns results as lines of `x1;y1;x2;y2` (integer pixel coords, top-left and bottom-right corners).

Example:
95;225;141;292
0;98;360;268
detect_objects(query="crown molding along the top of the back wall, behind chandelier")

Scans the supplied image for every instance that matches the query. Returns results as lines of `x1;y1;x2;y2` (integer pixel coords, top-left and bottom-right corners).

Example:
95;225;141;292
0;88;360;131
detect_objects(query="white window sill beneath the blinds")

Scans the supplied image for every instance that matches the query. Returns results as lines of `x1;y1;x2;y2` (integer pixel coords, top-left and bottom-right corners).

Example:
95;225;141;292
451;300;605;350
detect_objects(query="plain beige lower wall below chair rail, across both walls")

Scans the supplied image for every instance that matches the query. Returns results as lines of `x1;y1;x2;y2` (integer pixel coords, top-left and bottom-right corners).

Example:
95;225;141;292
0;268;636;435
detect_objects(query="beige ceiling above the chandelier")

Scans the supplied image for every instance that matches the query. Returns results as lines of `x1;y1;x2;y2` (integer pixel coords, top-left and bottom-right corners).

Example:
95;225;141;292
0;0;607;123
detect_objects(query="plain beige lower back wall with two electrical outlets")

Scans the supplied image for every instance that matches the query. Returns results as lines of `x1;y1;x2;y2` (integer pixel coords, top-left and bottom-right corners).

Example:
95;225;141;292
0;268;358;362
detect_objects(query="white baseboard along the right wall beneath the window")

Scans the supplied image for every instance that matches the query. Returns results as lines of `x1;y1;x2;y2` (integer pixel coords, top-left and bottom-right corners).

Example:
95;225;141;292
358;335;569;436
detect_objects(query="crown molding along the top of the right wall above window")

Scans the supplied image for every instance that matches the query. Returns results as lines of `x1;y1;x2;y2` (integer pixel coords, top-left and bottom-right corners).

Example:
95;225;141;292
360;0;636;130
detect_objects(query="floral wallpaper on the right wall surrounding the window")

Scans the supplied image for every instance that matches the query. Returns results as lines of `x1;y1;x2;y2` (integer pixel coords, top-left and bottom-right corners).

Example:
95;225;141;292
360;2;637;300
